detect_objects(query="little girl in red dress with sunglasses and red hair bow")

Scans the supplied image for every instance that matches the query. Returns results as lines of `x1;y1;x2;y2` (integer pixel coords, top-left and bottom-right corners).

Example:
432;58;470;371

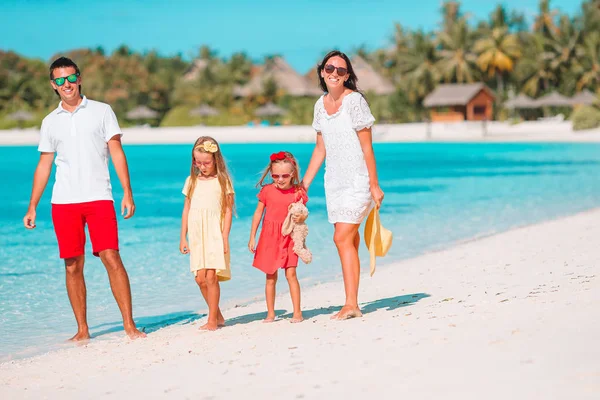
248;151;308;322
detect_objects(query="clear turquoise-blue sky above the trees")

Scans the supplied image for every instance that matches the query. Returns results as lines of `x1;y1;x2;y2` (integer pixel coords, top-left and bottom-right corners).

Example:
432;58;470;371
0;0;581;72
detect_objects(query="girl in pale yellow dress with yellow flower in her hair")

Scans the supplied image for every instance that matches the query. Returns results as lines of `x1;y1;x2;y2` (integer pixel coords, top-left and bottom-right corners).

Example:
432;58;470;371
179;136;234;330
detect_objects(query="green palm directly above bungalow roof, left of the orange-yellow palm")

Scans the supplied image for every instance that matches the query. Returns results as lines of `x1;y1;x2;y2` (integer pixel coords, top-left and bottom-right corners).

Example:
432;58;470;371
437;18;477;83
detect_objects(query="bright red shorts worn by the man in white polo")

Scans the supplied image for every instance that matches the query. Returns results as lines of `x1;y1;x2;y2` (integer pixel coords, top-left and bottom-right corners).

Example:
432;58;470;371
52;200;119;258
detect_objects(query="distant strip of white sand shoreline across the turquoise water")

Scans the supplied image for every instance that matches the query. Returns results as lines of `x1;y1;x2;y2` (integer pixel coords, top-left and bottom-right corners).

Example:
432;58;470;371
0;121;600;146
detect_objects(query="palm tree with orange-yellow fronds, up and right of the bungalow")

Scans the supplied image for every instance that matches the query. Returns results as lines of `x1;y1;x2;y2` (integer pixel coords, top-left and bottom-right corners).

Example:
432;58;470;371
474;25;521;93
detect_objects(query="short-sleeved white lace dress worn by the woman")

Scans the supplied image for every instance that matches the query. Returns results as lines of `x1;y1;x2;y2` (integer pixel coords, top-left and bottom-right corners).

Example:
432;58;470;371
313;92;375;224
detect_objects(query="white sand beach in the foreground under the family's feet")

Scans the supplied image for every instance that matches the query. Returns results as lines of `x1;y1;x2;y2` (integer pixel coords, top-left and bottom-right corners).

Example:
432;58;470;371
0;210;600;400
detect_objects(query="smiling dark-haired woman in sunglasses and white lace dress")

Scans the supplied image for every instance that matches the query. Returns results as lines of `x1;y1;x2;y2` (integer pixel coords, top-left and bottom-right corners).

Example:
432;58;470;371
303;51;383;320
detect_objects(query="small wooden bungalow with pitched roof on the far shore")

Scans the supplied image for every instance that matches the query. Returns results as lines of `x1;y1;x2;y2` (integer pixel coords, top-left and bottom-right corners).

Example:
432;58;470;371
423;83;495;122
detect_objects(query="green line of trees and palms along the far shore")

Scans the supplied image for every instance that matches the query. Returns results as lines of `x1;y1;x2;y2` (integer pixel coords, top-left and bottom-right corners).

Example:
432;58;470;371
0;0;600;128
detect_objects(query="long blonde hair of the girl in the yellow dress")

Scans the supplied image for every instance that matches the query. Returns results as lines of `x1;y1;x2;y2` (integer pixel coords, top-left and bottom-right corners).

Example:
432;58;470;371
187;136;235;221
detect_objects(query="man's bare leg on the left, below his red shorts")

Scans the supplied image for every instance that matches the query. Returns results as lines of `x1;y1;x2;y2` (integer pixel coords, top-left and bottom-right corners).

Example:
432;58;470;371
65;256;90;341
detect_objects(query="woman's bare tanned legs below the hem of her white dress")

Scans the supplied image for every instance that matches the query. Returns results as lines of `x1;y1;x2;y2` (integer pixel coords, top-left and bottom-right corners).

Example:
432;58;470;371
332;222;362;319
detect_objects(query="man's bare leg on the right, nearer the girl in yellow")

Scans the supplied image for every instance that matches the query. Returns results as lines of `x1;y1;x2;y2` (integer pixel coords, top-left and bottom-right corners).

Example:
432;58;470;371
100;250;146;339
